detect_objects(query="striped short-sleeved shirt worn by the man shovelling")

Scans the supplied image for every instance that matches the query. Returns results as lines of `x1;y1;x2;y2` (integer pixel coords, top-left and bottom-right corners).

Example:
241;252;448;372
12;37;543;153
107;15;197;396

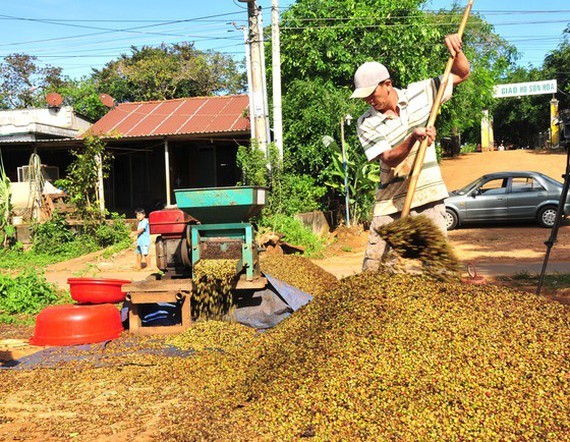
357;78;453;216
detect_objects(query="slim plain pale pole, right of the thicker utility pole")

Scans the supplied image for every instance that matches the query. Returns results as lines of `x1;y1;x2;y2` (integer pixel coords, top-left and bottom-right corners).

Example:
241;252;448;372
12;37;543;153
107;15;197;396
271;0;283;159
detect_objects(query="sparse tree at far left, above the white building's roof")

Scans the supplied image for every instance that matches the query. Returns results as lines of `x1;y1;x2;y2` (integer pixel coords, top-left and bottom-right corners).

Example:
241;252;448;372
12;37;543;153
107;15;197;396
0;54;65;109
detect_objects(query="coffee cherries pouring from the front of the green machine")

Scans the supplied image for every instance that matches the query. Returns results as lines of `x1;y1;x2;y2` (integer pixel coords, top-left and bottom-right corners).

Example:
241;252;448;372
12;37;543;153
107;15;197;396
192;259;238;320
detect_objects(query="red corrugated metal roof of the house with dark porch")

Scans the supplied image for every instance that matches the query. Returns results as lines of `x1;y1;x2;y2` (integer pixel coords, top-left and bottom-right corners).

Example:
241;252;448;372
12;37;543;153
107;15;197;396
89;95;250;137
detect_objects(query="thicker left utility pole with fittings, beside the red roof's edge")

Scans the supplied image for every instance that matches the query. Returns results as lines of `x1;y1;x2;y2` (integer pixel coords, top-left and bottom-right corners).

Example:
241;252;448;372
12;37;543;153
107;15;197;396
239;0;269;152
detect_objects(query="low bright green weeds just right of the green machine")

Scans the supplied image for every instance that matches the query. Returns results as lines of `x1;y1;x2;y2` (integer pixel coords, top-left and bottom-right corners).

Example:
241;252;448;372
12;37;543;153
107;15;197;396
258;214;325;258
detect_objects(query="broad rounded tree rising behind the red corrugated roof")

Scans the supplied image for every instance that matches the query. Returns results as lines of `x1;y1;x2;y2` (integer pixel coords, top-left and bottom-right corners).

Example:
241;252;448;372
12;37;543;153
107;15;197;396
92;42;245;102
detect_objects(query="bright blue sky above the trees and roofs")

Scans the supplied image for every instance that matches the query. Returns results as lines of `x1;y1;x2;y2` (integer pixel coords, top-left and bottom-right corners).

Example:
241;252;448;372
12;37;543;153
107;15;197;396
0;0;570;79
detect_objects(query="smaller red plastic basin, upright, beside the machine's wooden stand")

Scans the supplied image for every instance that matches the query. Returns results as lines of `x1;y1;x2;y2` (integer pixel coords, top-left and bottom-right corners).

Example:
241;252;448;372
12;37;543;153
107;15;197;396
67;278;131;304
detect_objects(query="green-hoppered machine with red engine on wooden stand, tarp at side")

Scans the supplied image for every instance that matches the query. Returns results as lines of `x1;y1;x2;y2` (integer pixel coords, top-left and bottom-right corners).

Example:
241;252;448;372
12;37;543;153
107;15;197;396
142;187;312;332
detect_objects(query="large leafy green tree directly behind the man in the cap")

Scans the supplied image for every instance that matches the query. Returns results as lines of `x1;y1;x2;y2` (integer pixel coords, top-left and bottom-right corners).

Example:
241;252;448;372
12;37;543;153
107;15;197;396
272;0;516;175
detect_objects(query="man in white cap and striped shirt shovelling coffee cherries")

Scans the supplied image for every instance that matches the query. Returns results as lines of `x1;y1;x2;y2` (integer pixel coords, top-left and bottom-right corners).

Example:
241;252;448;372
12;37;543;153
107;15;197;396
351;34;469;270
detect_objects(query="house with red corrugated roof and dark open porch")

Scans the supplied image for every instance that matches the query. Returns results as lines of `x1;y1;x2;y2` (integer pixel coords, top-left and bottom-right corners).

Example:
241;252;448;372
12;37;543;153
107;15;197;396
88;95;251;213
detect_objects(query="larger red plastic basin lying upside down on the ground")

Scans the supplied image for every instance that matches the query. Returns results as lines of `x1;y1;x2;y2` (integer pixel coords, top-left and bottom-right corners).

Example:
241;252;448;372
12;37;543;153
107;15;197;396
30;304;123;346
